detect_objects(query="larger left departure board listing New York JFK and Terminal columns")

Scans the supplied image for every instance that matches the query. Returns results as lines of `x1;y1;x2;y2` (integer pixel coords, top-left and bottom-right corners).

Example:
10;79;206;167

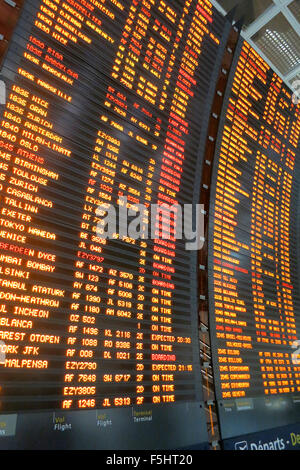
0;0;230;448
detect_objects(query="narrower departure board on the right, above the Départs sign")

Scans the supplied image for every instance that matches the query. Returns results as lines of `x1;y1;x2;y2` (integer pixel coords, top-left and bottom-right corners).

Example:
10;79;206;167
209;43;300;437
